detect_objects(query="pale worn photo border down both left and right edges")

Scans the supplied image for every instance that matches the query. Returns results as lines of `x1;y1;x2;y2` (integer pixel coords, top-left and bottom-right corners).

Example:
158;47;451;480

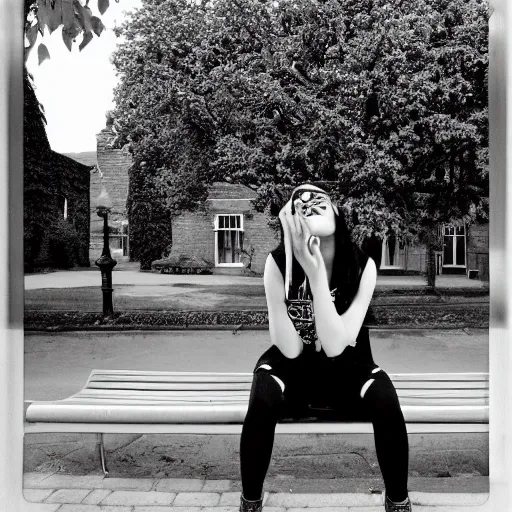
0;0;512;512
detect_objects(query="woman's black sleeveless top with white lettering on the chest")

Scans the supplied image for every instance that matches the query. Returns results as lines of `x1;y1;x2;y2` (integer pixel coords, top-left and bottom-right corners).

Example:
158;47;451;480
270;247;375;366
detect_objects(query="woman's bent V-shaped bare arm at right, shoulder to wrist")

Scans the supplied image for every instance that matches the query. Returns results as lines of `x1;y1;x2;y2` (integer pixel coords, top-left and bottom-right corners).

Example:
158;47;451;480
311;258;377;357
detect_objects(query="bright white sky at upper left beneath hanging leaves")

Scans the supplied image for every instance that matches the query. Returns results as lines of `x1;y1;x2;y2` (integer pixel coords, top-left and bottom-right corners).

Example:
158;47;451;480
27;0;141;153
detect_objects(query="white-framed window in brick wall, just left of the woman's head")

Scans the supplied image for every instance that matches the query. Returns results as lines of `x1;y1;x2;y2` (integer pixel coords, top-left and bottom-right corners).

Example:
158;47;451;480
215;214;244;267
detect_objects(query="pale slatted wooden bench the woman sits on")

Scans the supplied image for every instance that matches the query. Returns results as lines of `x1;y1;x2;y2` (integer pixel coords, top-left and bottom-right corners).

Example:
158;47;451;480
25;370;489;475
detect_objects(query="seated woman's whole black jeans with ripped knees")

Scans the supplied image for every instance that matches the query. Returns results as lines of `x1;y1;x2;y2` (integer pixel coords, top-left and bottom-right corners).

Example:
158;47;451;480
240;346;409;501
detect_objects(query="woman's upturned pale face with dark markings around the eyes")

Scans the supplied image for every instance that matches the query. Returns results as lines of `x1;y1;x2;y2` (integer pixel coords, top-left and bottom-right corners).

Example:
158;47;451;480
292;185;336;237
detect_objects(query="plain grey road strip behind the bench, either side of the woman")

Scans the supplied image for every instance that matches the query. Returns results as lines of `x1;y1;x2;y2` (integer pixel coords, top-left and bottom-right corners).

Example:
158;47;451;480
25;329;489;400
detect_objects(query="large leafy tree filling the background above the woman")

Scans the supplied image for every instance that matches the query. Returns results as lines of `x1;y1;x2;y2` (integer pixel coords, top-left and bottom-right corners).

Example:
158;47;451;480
113;0;488;286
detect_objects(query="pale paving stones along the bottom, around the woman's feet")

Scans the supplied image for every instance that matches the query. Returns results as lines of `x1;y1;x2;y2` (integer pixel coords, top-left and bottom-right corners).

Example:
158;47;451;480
24;473;488;512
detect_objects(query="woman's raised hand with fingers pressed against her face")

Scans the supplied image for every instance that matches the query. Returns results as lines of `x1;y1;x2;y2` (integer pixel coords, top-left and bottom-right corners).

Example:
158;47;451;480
286;204;327;282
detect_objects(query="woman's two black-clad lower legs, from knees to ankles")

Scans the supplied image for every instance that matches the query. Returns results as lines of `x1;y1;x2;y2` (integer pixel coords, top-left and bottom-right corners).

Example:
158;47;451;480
240;369;409;501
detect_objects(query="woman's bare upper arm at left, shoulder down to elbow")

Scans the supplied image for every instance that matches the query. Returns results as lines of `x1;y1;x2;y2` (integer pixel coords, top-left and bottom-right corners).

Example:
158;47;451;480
263;254;303;359
